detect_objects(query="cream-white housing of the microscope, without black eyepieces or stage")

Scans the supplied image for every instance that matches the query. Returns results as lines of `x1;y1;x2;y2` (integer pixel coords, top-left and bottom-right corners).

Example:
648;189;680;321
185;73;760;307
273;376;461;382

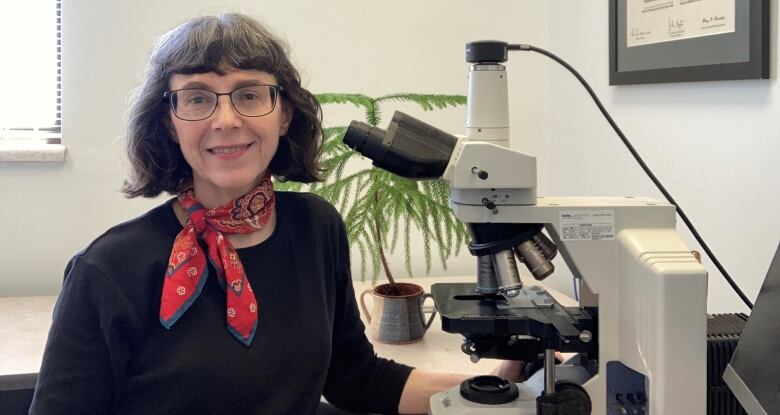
431;48;707;415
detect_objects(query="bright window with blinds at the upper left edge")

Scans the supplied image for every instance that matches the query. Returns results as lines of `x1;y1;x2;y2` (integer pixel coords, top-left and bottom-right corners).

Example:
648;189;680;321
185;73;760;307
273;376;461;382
0;0;62;143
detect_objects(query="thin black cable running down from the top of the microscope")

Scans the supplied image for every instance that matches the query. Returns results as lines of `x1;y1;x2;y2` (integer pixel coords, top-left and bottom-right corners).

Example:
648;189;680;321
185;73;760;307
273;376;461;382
508;44;753;310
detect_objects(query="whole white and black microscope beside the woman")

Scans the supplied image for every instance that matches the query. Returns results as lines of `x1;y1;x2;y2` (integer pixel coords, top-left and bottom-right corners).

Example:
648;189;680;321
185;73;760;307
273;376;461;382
344;41;707;415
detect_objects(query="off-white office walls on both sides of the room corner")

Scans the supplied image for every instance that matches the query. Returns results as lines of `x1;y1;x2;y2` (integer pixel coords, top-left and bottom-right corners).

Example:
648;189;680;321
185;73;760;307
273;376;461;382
0;0;780;312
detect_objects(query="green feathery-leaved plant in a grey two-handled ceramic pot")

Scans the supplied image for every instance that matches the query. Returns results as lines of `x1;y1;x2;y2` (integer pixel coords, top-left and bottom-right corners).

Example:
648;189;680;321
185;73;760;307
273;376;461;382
277;93;468;343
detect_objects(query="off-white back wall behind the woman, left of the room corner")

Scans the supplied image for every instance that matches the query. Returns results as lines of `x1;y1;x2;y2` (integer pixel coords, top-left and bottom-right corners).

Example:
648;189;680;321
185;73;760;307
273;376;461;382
0;0;547;296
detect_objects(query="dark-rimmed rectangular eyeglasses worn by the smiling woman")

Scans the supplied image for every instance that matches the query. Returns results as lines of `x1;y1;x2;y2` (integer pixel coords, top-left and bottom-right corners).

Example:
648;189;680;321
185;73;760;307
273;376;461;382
163;85;282;121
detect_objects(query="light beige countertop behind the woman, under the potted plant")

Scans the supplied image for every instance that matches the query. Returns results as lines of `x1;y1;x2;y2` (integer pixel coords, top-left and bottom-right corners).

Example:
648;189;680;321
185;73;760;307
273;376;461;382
0;277;576;376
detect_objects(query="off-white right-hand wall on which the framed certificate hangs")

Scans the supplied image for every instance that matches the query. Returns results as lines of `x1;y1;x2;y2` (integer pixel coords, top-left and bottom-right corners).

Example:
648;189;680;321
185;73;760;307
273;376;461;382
544;0;780;313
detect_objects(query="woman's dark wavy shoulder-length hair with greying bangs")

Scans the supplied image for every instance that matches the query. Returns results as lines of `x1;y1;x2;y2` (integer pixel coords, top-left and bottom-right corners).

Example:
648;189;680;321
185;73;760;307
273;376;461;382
122;14;322;197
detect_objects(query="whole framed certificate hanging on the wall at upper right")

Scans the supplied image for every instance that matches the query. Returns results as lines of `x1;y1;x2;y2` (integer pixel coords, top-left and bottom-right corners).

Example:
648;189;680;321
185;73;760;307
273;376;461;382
609;0;770;85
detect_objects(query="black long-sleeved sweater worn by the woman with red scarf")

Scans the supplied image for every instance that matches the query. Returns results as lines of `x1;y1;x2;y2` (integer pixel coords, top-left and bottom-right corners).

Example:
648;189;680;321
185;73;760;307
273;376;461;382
30;192;411;414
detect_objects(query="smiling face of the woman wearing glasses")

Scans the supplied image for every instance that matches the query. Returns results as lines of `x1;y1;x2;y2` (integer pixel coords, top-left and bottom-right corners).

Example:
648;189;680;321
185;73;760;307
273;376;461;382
169;68;292;207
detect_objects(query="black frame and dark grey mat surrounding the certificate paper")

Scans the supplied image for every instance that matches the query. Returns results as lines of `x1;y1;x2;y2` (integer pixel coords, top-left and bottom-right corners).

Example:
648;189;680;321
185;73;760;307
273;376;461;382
609;0;770;85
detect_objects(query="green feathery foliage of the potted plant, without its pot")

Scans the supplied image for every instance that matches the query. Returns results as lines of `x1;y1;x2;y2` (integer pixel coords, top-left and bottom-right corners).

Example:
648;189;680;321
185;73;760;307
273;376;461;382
304;93;468;280
